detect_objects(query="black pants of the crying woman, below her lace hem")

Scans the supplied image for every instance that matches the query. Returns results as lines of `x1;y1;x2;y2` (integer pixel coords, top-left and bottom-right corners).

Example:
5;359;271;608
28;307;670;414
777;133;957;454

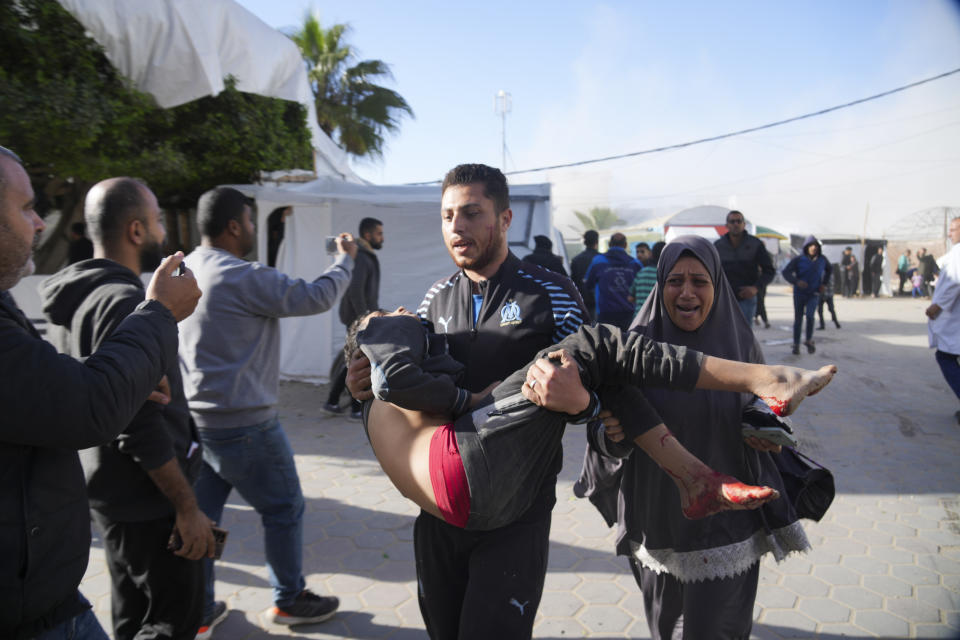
630;558;760;640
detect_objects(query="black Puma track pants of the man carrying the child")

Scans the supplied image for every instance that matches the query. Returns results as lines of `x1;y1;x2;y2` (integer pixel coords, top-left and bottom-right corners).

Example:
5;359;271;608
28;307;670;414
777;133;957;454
413;512;550;640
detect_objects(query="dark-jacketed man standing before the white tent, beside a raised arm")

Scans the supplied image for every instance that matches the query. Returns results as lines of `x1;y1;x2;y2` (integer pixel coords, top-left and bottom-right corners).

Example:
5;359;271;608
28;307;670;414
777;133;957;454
323;218;383;420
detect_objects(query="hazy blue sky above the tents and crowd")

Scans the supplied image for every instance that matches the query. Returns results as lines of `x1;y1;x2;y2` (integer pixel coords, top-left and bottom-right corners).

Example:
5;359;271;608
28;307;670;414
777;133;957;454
234;0;960;233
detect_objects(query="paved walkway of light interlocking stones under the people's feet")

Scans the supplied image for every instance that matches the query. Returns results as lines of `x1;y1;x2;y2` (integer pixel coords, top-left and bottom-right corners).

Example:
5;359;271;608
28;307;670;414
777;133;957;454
81;287;960;640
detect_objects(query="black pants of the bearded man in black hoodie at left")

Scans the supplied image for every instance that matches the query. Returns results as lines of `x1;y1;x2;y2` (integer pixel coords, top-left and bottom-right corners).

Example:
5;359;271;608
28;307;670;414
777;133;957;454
91;511;203;640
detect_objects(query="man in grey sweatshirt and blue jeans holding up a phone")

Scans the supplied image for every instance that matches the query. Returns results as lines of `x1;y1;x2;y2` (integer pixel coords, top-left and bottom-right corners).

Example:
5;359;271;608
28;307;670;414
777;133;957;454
180;187;357;637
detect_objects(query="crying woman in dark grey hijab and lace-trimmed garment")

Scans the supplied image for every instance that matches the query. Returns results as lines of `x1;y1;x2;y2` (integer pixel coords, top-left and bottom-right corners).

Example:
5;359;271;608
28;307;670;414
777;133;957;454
575;236;810;640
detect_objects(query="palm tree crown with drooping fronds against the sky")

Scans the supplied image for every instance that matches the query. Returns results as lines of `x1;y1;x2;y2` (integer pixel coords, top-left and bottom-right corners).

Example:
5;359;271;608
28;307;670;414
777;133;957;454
291;13;413;158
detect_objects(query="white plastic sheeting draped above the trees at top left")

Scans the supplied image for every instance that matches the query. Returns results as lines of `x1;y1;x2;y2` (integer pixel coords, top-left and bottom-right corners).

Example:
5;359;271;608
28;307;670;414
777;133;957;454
59;0;363;183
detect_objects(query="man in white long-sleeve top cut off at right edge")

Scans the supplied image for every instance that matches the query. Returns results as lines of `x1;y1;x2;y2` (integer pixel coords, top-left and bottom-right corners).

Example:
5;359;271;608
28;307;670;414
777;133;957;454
926;218;960;423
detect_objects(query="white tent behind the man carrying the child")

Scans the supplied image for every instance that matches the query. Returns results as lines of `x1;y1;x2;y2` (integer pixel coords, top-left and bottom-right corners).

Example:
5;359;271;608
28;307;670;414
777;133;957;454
233;178;562;380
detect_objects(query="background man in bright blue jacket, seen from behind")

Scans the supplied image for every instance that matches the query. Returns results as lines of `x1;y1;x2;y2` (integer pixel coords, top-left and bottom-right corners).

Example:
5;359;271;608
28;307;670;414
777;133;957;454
585;233;643;331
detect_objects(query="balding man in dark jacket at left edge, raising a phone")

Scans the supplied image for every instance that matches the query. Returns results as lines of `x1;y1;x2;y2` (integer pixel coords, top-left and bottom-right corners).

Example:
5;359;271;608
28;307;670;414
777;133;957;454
0;147;200;640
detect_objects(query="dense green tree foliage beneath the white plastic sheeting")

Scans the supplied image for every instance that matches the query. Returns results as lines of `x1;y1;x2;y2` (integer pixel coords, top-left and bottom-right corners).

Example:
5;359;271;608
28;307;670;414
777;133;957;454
0;0;313;268
